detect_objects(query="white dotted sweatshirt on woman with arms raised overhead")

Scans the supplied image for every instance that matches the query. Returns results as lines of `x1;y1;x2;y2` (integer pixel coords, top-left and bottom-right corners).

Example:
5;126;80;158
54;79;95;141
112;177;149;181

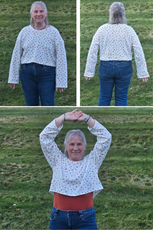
40;120;111;197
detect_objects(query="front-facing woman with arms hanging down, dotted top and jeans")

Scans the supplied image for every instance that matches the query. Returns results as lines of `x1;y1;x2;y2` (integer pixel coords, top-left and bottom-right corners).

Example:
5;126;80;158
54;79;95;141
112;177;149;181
8;1;67;106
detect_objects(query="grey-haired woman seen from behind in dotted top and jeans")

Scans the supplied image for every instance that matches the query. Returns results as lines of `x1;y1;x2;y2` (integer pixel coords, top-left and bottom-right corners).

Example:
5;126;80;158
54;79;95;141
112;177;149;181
84;2;149;106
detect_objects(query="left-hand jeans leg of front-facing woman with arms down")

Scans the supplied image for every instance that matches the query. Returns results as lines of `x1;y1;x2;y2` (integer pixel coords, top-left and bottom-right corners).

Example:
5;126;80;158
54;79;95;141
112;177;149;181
20;64;39;106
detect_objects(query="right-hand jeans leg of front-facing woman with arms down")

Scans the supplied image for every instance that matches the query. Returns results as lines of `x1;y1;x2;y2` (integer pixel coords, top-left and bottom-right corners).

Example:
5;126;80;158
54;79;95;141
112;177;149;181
37;65;56;106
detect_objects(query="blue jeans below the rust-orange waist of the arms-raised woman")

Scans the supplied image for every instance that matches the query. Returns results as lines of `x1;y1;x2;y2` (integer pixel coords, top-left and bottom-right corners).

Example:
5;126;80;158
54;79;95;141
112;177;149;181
49;207;98;230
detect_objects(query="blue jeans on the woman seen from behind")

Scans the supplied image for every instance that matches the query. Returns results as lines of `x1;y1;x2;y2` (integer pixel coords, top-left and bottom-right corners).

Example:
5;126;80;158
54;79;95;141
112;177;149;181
98;61;133;106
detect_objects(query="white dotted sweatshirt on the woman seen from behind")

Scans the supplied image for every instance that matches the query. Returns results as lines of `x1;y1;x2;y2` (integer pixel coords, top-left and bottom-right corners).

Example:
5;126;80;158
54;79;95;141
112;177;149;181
84;24;149;78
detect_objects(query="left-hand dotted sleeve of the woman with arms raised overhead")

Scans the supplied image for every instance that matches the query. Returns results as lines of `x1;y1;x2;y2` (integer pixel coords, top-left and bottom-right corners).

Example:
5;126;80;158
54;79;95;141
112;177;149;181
39;119;63;168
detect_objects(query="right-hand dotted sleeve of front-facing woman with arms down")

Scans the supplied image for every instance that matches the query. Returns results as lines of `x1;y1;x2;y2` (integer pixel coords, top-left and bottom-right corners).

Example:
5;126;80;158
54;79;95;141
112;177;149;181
56;32;67;88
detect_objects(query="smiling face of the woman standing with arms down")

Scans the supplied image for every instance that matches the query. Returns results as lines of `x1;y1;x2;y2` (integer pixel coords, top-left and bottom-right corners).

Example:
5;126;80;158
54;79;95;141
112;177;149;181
31;5;47;23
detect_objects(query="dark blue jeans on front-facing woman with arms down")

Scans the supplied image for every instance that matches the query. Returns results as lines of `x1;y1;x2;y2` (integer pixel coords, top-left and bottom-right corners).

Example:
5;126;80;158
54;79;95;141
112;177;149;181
20;63;56;106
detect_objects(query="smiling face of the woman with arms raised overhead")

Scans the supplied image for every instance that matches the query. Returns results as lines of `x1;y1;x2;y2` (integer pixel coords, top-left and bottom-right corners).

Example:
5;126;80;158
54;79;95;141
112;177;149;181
65;137;86;161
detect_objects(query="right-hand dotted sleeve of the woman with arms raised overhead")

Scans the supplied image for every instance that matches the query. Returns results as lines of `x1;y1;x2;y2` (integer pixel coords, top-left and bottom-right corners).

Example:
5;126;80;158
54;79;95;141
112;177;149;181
88;120;112;169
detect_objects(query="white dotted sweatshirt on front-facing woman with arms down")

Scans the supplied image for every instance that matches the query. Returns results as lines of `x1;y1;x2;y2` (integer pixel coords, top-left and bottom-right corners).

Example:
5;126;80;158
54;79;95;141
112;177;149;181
8;25;67;88
